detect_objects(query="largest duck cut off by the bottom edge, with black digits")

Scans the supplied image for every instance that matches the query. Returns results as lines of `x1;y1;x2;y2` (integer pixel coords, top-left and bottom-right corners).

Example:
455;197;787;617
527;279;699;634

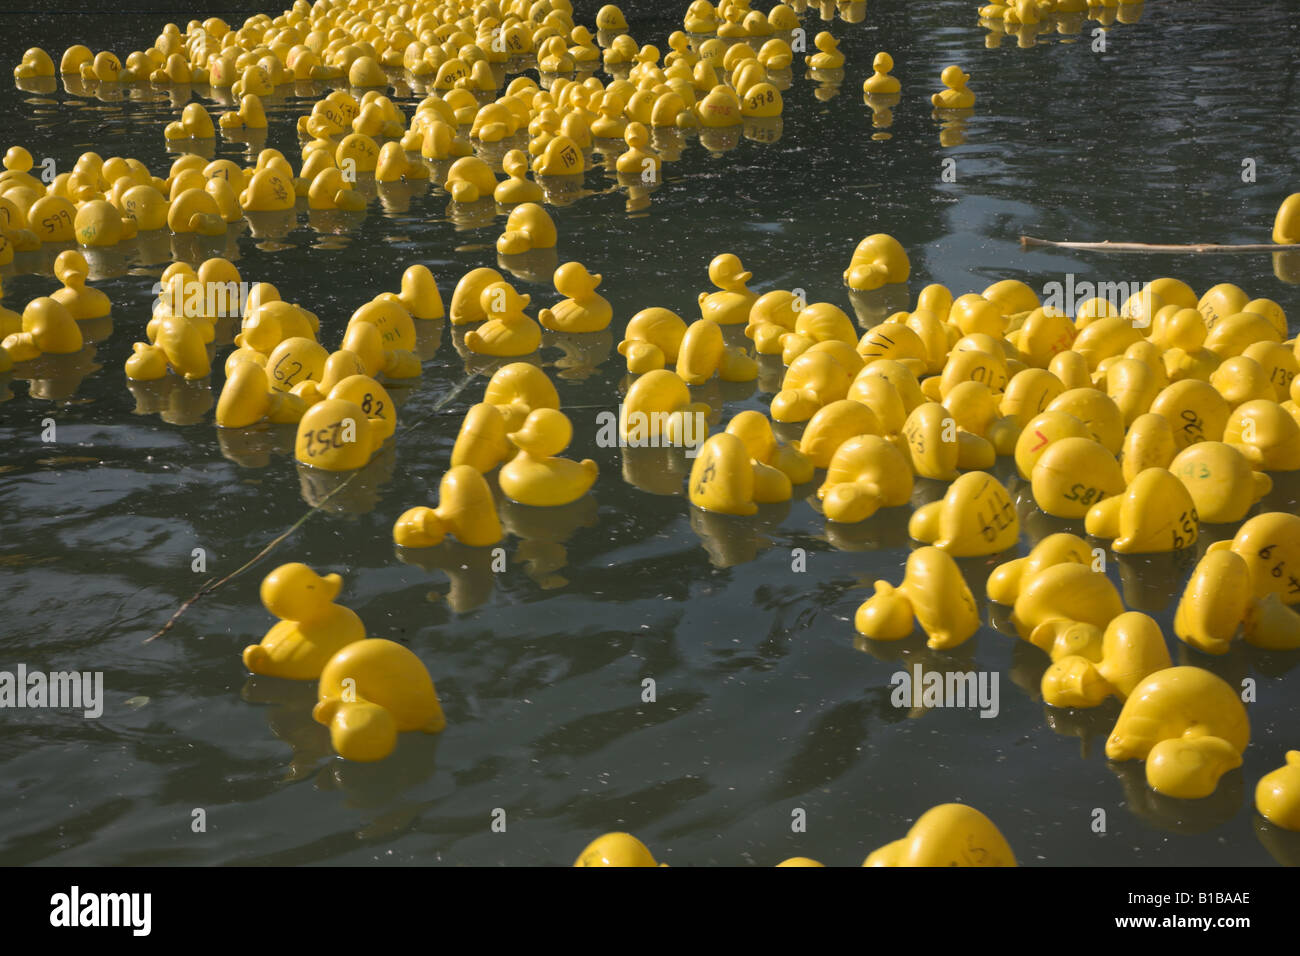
862;804;1015;866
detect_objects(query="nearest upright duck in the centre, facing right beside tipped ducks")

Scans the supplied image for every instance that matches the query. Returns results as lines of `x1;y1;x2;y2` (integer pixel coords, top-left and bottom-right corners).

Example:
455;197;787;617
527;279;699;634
501;408;597;507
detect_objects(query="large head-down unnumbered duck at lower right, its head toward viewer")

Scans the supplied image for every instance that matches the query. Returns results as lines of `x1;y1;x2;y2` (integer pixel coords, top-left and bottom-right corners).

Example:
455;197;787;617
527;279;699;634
1106;667;1251;800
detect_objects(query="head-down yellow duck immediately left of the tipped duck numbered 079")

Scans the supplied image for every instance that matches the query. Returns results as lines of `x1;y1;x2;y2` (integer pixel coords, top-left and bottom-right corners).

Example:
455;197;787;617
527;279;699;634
816;434;913;524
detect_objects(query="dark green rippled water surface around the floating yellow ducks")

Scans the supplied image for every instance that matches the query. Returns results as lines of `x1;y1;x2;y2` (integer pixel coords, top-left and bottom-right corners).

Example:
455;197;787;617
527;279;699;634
0;0;1300;865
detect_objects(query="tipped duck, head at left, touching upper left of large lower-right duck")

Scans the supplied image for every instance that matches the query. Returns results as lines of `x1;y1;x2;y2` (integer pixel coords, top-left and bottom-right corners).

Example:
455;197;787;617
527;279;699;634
1041;611;1173;708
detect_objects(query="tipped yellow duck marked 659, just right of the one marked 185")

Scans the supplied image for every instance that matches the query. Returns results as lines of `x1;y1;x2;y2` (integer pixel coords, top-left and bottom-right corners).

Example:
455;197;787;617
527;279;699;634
1084;468;1200;554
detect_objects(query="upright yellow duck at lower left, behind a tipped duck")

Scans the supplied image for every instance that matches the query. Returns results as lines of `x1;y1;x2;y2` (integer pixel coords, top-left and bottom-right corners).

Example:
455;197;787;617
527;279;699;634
243;562;365;680
